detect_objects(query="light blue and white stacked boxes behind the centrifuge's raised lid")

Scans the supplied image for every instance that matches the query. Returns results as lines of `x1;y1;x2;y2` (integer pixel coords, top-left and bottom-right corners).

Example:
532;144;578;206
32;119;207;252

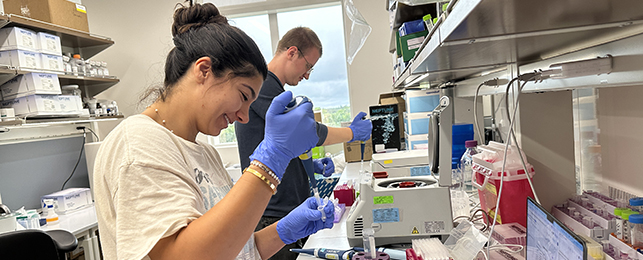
404;89;440;150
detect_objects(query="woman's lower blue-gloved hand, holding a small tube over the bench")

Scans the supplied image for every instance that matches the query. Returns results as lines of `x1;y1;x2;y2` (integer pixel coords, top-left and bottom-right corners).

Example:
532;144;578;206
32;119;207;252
277;197;335;244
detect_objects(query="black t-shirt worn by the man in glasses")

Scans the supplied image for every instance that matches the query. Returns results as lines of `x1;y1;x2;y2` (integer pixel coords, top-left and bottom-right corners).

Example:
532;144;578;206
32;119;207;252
234;71;328;218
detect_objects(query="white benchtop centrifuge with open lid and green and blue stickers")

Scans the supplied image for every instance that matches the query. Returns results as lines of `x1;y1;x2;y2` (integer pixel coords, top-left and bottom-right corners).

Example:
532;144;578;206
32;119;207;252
346;89;453;246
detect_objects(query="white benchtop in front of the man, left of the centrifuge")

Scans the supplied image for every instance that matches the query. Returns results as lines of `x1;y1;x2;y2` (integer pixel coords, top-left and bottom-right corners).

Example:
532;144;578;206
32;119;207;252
297;162;362;260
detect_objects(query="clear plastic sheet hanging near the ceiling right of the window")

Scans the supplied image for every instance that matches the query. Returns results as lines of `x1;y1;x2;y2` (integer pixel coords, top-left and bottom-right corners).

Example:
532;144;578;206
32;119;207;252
344;0;372;64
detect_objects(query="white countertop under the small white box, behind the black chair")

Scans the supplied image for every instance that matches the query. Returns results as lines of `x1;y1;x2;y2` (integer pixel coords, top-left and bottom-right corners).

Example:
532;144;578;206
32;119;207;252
42;205;98;235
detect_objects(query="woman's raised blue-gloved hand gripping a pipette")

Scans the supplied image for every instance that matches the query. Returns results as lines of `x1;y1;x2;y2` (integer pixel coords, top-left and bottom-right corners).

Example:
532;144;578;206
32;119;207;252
250;91;319;180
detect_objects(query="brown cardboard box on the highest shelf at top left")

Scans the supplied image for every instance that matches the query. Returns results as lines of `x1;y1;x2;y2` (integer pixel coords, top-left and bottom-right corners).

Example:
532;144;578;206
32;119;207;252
3;0;89;32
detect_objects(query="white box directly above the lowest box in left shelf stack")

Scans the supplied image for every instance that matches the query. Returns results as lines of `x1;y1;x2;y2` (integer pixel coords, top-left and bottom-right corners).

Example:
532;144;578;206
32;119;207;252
0;72;61;100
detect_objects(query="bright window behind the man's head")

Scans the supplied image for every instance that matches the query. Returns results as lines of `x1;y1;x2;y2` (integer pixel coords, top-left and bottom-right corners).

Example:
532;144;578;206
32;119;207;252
205;1;351;145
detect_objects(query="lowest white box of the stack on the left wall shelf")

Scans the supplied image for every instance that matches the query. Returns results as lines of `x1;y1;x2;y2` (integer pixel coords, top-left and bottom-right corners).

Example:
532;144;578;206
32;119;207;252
1;95;80;117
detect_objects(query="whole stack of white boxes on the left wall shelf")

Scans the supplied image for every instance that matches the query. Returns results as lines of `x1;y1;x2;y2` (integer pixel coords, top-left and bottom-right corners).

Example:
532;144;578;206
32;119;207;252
0;27;82;117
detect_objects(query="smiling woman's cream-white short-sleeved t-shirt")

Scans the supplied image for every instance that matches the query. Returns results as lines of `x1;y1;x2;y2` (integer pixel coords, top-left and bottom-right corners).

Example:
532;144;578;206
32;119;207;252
93;114;261;259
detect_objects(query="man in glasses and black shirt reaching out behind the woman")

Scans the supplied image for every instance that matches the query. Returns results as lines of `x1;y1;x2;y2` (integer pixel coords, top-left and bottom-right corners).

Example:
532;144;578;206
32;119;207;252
235;27;373;260
